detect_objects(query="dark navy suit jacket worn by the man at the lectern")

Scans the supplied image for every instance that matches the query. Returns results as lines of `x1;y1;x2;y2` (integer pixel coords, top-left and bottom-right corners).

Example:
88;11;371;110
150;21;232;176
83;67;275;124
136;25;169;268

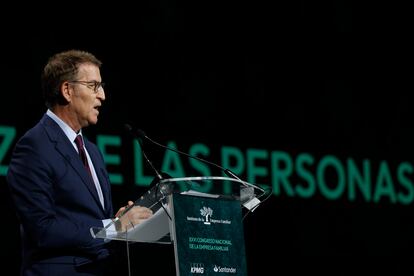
7;115;113;275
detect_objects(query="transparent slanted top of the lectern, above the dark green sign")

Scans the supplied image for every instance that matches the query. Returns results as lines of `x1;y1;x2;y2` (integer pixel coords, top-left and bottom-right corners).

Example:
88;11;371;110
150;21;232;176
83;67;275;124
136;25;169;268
91;176;264;243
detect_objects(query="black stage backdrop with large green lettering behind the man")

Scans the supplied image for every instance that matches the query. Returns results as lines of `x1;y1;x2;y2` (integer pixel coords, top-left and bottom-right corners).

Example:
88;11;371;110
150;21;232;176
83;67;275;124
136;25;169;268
0;1;414;275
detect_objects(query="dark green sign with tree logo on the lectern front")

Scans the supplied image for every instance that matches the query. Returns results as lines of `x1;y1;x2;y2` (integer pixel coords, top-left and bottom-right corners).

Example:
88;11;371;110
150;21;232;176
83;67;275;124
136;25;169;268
172;193;247;276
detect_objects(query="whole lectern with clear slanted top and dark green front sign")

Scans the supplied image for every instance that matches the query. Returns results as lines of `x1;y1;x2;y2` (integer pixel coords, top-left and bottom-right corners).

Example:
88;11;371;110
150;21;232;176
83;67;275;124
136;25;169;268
91;176;265;276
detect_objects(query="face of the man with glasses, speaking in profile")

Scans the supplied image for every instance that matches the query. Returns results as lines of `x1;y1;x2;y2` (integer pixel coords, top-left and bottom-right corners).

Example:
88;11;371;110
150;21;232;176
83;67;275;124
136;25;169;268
70;63;105;128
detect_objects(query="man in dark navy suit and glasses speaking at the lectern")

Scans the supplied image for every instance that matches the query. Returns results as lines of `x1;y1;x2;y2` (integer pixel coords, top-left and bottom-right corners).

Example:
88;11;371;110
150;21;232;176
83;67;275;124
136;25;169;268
7;50;152;275
